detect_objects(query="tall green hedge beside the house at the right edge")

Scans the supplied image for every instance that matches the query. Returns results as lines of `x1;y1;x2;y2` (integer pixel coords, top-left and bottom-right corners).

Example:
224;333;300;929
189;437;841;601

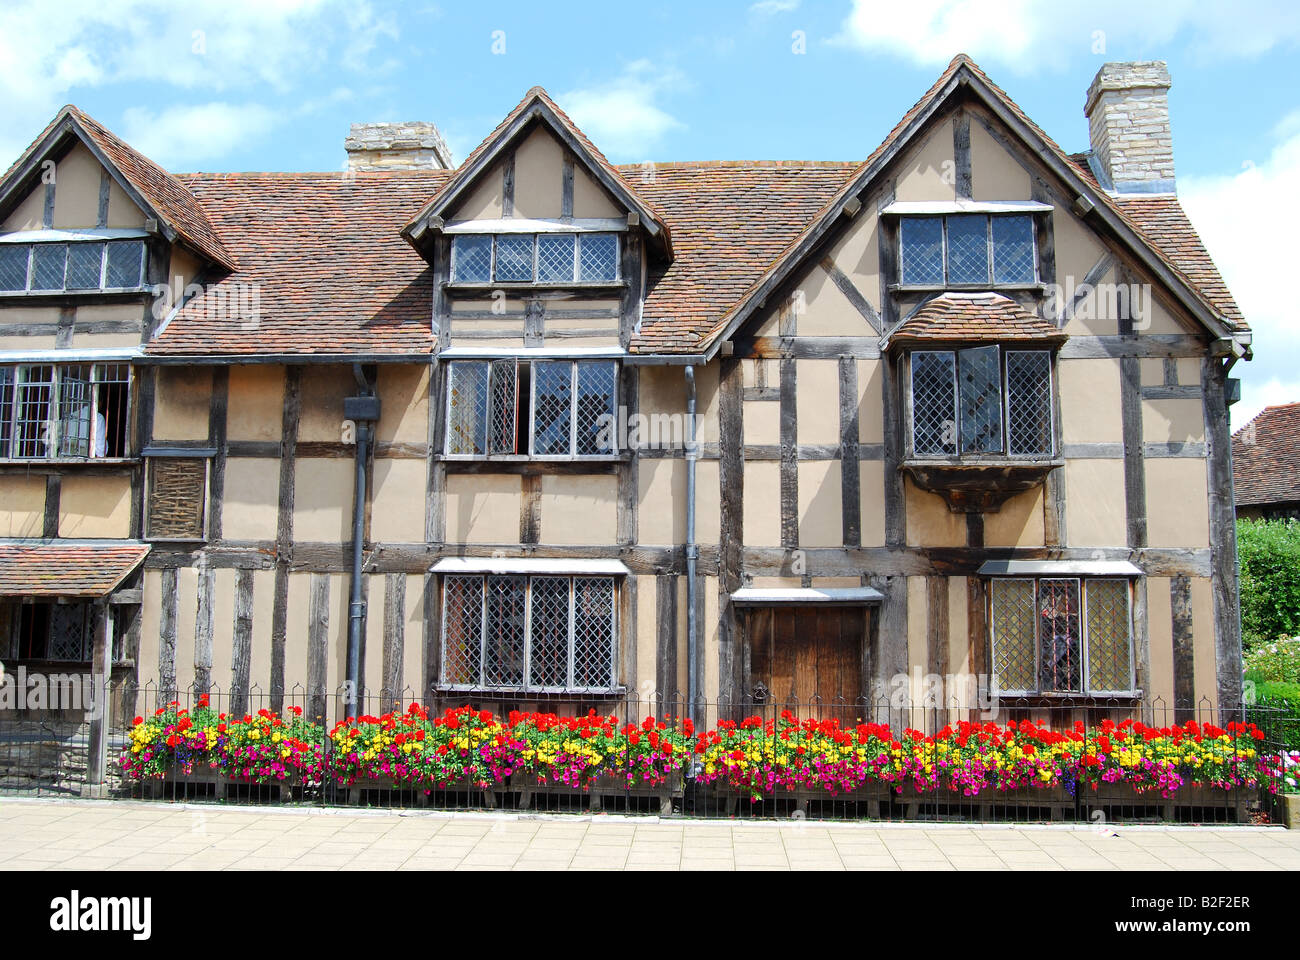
1236;520;1300;647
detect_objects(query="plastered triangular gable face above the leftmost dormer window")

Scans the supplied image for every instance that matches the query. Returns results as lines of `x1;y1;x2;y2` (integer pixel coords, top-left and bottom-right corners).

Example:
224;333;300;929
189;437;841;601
0;142;146;233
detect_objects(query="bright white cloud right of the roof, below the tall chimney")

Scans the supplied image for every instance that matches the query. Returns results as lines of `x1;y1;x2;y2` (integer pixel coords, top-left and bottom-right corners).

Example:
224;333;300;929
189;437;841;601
1178;123;1300;425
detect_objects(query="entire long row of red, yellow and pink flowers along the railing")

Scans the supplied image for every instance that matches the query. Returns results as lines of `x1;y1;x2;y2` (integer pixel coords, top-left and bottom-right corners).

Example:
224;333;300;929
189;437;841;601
121;699;1274;801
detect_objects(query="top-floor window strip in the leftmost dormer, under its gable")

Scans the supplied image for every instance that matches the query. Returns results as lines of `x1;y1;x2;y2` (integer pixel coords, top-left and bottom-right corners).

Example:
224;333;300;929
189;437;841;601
0;239;144;293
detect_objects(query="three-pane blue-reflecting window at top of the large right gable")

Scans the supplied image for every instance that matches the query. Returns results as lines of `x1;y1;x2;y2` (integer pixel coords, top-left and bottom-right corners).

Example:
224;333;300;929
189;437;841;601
900;213;1037;287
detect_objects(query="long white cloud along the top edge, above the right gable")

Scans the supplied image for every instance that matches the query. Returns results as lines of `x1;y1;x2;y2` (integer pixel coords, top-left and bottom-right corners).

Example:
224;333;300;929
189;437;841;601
833;0;1300;73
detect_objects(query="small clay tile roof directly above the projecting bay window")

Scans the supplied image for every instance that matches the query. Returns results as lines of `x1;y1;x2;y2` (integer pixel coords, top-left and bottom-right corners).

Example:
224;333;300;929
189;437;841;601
889;293;1066;345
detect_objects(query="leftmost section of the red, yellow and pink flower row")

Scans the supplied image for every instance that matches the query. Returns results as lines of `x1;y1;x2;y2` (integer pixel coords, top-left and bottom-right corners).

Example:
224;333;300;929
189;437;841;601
120;697;324;786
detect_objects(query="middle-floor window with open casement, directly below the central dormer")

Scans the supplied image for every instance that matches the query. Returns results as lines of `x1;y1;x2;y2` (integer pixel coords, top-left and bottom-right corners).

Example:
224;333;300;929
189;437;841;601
446;359;619;459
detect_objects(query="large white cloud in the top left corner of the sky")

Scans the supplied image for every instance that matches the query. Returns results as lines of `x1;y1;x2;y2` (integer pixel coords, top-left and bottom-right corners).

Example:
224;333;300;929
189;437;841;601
0;0;395;167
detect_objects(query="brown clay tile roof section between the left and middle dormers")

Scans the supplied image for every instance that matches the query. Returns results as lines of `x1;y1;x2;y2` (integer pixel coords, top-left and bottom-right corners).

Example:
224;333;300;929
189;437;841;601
147;170;447;356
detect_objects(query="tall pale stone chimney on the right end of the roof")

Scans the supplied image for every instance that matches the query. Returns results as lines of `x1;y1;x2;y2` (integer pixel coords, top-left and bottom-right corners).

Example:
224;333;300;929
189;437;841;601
1083;60;1174;194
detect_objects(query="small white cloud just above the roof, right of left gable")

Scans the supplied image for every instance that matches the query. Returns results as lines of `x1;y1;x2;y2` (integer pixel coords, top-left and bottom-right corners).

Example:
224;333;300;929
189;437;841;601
121;103;276;170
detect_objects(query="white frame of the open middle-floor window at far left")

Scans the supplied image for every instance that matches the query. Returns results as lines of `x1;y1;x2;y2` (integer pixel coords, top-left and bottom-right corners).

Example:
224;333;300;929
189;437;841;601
0;360;138;463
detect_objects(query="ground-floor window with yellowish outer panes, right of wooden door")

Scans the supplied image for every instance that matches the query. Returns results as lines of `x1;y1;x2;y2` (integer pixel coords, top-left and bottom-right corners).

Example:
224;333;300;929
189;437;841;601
989;578;1134;693
